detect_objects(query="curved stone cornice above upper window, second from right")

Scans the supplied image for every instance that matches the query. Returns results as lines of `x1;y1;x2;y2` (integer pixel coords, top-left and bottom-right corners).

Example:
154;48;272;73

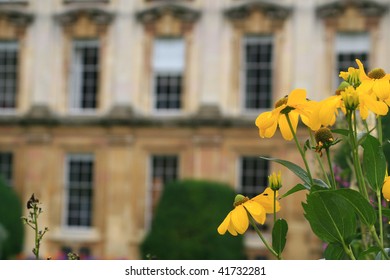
224;0;291;20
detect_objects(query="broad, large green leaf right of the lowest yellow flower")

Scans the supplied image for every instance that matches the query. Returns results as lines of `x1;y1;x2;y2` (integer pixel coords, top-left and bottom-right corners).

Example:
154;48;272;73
302;190;356;243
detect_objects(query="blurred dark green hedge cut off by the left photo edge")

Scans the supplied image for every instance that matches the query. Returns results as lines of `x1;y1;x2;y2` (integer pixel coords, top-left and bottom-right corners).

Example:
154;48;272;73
0;178;24;259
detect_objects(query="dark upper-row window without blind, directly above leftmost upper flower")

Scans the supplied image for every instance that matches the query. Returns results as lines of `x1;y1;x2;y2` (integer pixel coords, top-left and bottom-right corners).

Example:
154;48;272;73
243;36;273;109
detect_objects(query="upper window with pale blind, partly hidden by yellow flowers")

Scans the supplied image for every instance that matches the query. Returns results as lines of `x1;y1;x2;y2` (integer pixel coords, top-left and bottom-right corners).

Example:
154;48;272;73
335;33;370;87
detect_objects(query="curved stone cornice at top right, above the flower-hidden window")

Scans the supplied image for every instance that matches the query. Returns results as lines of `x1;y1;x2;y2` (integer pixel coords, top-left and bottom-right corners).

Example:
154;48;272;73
316;0;387;18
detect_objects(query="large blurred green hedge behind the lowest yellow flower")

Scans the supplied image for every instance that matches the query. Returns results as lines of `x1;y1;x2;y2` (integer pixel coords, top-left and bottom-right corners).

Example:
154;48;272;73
141;180;244;260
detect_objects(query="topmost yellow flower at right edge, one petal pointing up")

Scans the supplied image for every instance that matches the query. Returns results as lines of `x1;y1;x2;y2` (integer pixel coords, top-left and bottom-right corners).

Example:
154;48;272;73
356;59;390;100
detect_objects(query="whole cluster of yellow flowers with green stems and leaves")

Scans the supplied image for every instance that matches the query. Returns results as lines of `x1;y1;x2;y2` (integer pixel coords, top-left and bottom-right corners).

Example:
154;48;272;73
218;59;390;259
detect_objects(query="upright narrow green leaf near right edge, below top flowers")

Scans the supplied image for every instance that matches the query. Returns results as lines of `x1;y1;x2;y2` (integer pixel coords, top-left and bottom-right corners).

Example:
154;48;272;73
362;135;386;191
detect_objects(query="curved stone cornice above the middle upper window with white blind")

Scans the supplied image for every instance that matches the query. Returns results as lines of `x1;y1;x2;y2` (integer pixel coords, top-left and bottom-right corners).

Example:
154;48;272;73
136;3;200;23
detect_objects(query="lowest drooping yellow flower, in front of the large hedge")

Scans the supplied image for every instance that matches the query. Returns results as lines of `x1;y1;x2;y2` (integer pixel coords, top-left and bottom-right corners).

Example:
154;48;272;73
217;188;280;236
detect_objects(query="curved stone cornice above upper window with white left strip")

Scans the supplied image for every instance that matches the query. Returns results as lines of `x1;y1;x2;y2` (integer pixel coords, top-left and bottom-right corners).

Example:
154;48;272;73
55;7;114;25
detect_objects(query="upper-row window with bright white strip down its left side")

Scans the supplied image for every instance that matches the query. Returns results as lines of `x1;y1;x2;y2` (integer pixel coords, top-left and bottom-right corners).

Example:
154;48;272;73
70;40;99;111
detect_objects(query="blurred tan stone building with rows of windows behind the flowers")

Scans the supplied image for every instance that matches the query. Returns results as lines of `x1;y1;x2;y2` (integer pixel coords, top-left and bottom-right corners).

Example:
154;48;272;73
0;0;390;259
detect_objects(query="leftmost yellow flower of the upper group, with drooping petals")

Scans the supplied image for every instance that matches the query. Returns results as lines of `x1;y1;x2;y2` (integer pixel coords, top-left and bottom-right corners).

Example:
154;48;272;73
256;89;319;140
